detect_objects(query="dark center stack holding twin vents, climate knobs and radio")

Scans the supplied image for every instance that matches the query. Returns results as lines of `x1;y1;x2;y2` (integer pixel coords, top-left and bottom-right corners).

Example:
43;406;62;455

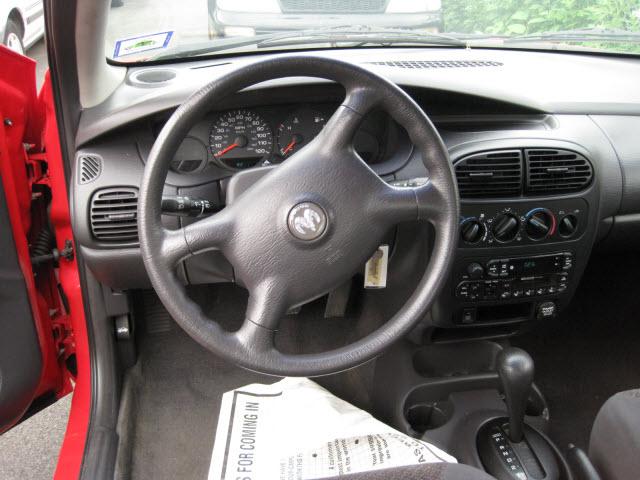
430;149;598;340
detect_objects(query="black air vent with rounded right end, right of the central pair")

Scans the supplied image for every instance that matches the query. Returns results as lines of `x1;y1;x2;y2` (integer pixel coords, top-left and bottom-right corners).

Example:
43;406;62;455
525;149;593;195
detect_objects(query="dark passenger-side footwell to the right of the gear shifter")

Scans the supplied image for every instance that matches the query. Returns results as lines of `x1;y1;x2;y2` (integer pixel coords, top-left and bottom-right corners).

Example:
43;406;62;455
513;255;640;449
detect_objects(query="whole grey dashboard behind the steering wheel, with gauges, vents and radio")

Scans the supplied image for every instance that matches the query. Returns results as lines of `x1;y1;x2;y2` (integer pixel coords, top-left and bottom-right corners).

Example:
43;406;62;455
71;49;640;339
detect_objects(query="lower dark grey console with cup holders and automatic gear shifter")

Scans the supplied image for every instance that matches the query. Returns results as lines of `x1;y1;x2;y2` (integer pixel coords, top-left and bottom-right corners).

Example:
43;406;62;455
373;340;574;480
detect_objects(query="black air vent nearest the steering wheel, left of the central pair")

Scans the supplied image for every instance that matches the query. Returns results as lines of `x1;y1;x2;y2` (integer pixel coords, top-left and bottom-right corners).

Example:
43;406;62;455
455;150;522;198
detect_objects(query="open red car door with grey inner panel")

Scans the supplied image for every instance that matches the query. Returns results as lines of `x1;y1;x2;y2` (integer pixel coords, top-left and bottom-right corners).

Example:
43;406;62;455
0;45;76;433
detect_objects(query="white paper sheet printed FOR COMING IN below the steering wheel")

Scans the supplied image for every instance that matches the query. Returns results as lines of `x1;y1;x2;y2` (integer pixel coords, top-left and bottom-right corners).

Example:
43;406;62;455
209;378;456;480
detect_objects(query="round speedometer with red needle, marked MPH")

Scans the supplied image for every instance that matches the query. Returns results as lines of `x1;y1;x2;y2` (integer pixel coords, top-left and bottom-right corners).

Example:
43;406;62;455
209;110;273;169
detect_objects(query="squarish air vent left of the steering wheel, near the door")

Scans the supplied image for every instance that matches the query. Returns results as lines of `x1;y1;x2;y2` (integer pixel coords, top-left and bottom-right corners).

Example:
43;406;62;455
89;187;138;243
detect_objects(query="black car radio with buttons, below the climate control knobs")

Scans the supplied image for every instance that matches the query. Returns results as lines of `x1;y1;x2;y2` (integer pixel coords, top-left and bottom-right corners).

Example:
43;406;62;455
456;252;574;302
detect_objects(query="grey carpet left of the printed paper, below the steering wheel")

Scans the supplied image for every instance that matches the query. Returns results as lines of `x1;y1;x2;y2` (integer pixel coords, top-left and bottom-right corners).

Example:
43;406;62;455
117;286;270;479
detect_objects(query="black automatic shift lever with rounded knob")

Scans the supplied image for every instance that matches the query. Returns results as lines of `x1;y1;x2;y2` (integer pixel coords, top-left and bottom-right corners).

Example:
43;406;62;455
496;347;534;443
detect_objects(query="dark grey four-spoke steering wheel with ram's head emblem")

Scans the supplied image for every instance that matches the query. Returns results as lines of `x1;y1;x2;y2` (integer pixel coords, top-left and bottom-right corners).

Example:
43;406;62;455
138;55;459;376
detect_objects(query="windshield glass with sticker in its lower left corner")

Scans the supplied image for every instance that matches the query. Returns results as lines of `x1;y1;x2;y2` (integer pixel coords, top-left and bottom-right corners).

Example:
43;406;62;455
106;0;640;62
